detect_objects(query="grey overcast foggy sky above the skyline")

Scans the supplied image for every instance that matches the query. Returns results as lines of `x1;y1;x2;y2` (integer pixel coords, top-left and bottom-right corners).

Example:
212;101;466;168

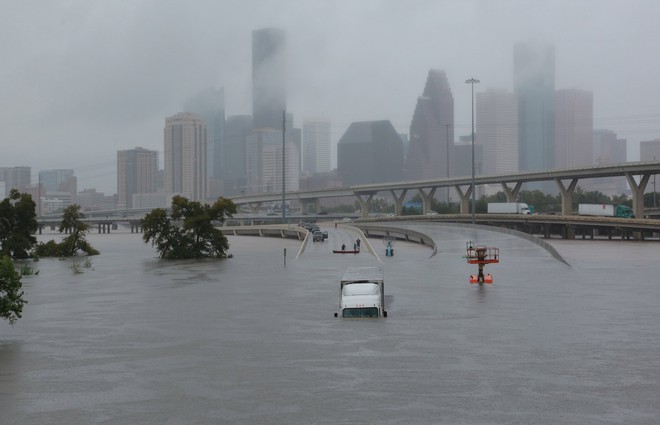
0;0;660;194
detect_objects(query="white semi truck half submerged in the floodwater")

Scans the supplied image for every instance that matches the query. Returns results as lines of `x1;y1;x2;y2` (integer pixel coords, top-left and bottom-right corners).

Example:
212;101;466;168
335;267;387;317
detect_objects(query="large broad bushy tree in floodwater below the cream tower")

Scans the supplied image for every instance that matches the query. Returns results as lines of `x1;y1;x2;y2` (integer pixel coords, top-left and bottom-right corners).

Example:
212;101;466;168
142;196;236;258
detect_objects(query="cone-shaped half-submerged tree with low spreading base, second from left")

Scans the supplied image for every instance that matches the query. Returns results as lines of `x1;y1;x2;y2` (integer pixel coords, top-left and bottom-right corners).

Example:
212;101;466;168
35;205;99;257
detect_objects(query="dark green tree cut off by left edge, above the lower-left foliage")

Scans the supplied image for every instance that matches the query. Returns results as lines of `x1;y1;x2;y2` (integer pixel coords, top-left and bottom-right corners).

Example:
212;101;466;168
0;189;38;258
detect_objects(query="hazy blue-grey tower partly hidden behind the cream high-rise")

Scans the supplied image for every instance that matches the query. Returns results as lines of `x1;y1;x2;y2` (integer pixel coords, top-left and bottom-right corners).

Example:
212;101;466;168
183;88;226;180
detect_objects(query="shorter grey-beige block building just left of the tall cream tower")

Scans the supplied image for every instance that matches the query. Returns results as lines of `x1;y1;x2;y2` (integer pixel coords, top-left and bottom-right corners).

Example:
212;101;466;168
117;147;158;210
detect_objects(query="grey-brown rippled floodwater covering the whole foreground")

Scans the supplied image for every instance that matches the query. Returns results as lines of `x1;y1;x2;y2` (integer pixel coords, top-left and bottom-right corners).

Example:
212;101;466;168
0;224;660;425
